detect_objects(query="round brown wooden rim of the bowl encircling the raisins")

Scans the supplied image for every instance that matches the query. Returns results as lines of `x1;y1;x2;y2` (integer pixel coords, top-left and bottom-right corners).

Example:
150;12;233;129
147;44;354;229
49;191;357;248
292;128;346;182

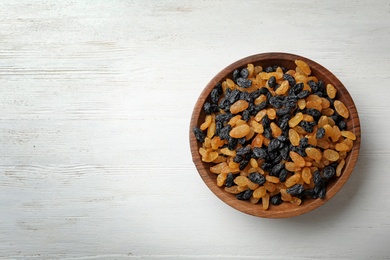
189;52;361;218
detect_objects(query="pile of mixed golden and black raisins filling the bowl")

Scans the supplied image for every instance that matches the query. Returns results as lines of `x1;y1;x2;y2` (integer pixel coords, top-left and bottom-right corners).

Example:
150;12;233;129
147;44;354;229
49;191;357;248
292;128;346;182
193;60;356;209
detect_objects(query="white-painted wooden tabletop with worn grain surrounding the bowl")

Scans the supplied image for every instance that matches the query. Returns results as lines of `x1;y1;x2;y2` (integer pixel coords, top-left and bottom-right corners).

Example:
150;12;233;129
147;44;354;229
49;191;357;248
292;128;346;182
0;0;390;259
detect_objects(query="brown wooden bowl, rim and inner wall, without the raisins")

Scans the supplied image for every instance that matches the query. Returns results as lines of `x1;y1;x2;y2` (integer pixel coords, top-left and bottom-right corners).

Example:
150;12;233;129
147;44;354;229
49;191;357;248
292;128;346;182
190;53;361;218
